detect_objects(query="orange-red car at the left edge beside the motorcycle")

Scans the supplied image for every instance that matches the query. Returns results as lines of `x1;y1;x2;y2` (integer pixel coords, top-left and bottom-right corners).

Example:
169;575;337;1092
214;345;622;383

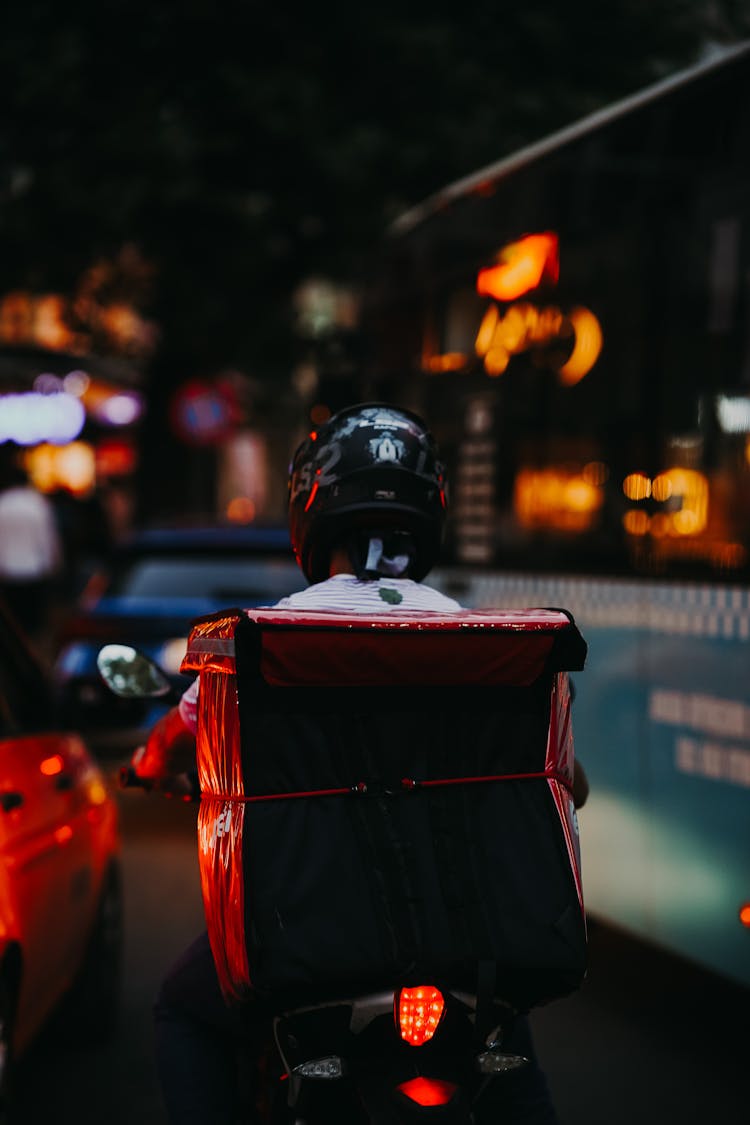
0;602;121;1121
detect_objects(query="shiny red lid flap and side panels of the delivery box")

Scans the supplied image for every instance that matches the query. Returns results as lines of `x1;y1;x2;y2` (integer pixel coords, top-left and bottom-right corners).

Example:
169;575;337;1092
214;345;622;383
182;609;582;998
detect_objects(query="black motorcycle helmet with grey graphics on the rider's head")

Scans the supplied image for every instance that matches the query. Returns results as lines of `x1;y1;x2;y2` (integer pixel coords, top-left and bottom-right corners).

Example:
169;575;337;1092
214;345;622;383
289;403;446;583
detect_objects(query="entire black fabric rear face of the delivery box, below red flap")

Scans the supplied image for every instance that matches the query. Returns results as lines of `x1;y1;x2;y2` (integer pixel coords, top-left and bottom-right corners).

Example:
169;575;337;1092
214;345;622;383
237;616;586;1009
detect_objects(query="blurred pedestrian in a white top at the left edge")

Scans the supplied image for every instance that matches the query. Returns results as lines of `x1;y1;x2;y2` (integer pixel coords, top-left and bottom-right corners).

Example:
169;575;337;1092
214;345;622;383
0;447;63;648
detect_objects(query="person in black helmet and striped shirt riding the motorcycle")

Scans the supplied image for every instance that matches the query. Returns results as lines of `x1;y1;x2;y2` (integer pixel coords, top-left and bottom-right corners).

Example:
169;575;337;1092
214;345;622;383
133;403;587;1125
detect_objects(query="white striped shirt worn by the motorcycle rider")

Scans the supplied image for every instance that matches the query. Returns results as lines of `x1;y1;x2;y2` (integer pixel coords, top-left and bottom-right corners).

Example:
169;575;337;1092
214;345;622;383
179;574;463;731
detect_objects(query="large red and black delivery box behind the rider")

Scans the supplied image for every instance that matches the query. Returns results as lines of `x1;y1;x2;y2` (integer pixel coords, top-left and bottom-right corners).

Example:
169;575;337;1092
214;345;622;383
182;609;586;1010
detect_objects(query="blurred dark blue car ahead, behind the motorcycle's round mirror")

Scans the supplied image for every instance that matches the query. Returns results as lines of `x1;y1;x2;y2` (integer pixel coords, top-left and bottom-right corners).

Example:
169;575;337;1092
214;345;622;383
54;525;307;753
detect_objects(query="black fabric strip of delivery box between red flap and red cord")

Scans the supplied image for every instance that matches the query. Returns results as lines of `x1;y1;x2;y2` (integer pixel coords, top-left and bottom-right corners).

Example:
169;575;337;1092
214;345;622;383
240;677;550;795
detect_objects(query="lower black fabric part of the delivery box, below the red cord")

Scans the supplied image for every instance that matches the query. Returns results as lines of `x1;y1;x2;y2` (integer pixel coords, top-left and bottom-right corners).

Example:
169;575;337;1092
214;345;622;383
244;782;585;1008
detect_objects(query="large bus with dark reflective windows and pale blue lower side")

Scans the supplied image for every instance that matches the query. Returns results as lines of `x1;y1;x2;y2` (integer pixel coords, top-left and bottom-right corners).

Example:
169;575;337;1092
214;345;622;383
365;43;750;987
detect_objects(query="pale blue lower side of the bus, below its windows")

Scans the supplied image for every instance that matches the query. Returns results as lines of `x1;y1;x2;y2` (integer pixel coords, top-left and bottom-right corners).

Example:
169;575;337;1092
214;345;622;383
435;573;750;984
